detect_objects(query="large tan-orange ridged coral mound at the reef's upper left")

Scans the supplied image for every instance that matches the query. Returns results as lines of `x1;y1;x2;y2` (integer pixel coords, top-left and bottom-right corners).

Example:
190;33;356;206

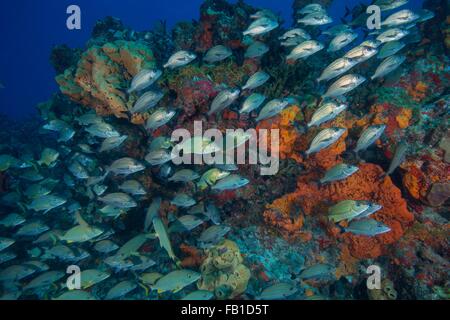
56;40;155;118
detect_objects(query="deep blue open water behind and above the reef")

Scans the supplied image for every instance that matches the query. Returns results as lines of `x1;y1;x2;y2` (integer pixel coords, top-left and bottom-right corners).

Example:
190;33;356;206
0;0;422;119
